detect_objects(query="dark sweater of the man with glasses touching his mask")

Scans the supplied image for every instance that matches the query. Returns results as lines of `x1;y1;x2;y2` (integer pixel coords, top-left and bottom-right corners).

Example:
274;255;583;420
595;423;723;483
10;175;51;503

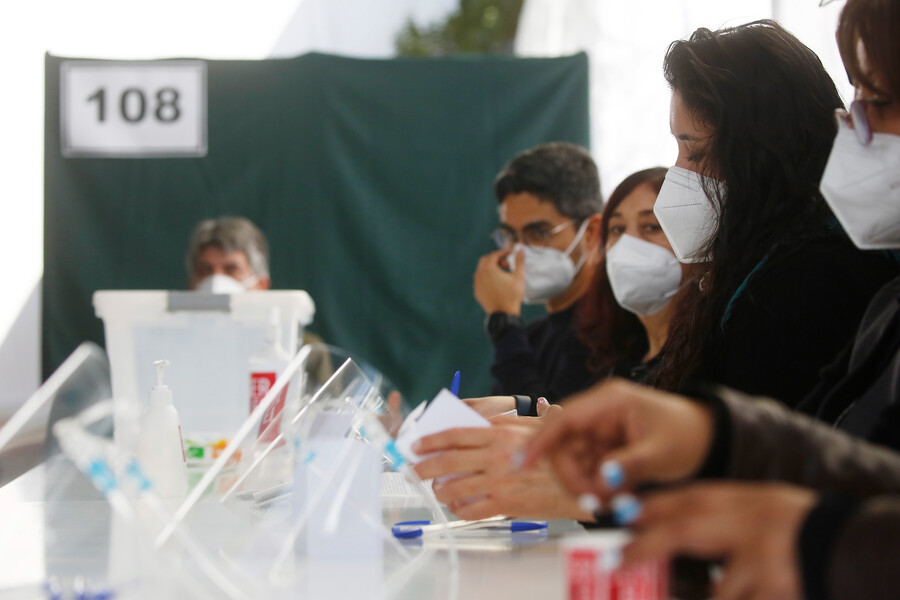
491;306;596;404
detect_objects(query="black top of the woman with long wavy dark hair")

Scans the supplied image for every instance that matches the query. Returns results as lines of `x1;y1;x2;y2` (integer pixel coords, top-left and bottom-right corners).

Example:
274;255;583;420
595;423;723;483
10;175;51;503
695;233;900;407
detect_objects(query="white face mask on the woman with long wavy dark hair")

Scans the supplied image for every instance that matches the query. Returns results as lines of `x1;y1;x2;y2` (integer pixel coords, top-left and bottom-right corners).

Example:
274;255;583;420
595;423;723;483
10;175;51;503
653;167;722;263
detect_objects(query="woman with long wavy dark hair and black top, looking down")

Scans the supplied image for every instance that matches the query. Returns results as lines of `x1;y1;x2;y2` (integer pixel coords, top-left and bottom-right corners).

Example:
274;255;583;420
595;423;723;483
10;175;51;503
653;21;897;406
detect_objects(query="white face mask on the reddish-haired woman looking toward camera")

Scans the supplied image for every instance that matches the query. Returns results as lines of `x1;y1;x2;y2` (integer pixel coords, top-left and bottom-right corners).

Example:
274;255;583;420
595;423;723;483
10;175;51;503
606;235;681;317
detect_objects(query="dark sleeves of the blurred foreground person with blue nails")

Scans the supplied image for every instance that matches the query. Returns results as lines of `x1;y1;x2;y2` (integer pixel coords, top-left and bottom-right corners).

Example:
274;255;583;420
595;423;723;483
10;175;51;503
701;389;900;600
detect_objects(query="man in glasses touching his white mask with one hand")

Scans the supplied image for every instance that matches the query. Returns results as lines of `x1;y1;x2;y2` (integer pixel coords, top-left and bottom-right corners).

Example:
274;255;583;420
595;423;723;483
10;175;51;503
474;143;602;415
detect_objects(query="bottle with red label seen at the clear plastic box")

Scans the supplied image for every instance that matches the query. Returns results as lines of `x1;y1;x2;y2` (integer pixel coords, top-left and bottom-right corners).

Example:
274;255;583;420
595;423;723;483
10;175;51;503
250;308;291;441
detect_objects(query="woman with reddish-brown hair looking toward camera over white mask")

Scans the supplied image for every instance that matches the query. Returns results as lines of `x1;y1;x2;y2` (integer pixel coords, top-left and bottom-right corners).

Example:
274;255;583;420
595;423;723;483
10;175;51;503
578;167;683;382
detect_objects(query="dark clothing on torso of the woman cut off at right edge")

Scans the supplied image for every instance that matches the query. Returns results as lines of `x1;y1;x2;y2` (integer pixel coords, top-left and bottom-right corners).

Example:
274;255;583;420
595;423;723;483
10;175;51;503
798;278;900;450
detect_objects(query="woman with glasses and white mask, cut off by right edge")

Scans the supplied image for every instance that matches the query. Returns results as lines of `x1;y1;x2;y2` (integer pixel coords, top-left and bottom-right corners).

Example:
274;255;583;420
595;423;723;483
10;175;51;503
799;1;900;450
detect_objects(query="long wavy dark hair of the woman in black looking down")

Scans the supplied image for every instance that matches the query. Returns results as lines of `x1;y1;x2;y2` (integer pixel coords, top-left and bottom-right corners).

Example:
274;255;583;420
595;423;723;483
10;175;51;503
654;20;842;389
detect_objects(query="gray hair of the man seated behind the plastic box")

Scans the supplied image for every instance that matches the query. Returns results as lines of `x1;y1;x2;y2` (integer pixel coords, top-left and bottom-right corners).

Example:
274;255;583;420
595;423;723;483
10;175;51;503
184;217;269;279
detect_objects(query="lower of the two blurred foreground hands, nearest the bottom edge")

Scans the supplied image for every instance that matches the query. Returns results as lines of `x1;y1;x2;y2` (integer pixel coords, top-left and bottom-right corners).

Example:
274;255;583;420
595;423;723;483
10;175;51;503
623;483;816;600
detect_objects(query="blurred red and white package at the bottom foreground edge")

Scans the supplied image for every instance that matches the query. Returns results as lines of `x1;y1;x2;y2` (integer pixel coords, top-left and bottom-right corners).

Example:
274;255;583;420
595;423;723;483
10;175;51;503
560;530;669;600
